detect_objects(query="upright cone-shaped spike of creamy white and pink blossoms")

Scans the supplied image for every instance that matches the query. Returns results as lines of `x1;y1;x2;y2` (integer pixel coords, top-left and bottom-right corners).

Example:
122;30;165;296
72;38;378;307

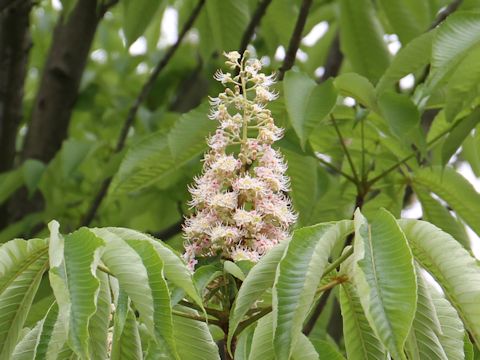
183;51;296;270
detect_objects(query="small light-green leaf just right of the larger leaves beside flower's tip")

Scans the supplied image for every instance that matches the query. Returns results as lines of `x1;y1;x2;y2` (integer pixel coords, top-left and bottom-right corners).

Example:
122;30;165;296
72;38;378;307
333;73;378;112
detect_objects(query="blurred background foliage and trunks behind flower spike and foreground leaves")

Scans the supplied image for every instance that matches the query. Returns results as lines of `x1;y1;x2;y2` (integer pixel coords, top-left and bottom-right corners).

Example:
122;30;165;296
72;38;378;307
0;0;480;258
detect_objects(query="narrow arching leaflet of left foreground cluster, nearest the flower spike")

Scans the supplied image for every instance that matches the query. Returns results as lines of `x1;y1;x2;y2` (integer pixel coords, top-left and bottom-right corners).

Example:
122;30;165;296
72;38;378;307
92;227;203;306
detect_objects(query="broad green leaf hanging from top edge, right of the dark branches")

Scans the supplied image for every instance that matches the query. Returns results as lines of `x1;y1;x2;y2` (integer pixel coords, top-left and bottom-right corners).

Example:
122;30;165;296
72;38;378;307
339;0;390;83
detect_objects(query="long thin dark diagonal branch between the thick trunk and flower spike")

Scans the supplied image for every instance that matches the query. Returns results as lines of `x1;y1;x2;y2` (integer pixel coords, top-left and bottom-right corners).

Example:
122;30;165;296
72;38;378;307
81;0;205;226
